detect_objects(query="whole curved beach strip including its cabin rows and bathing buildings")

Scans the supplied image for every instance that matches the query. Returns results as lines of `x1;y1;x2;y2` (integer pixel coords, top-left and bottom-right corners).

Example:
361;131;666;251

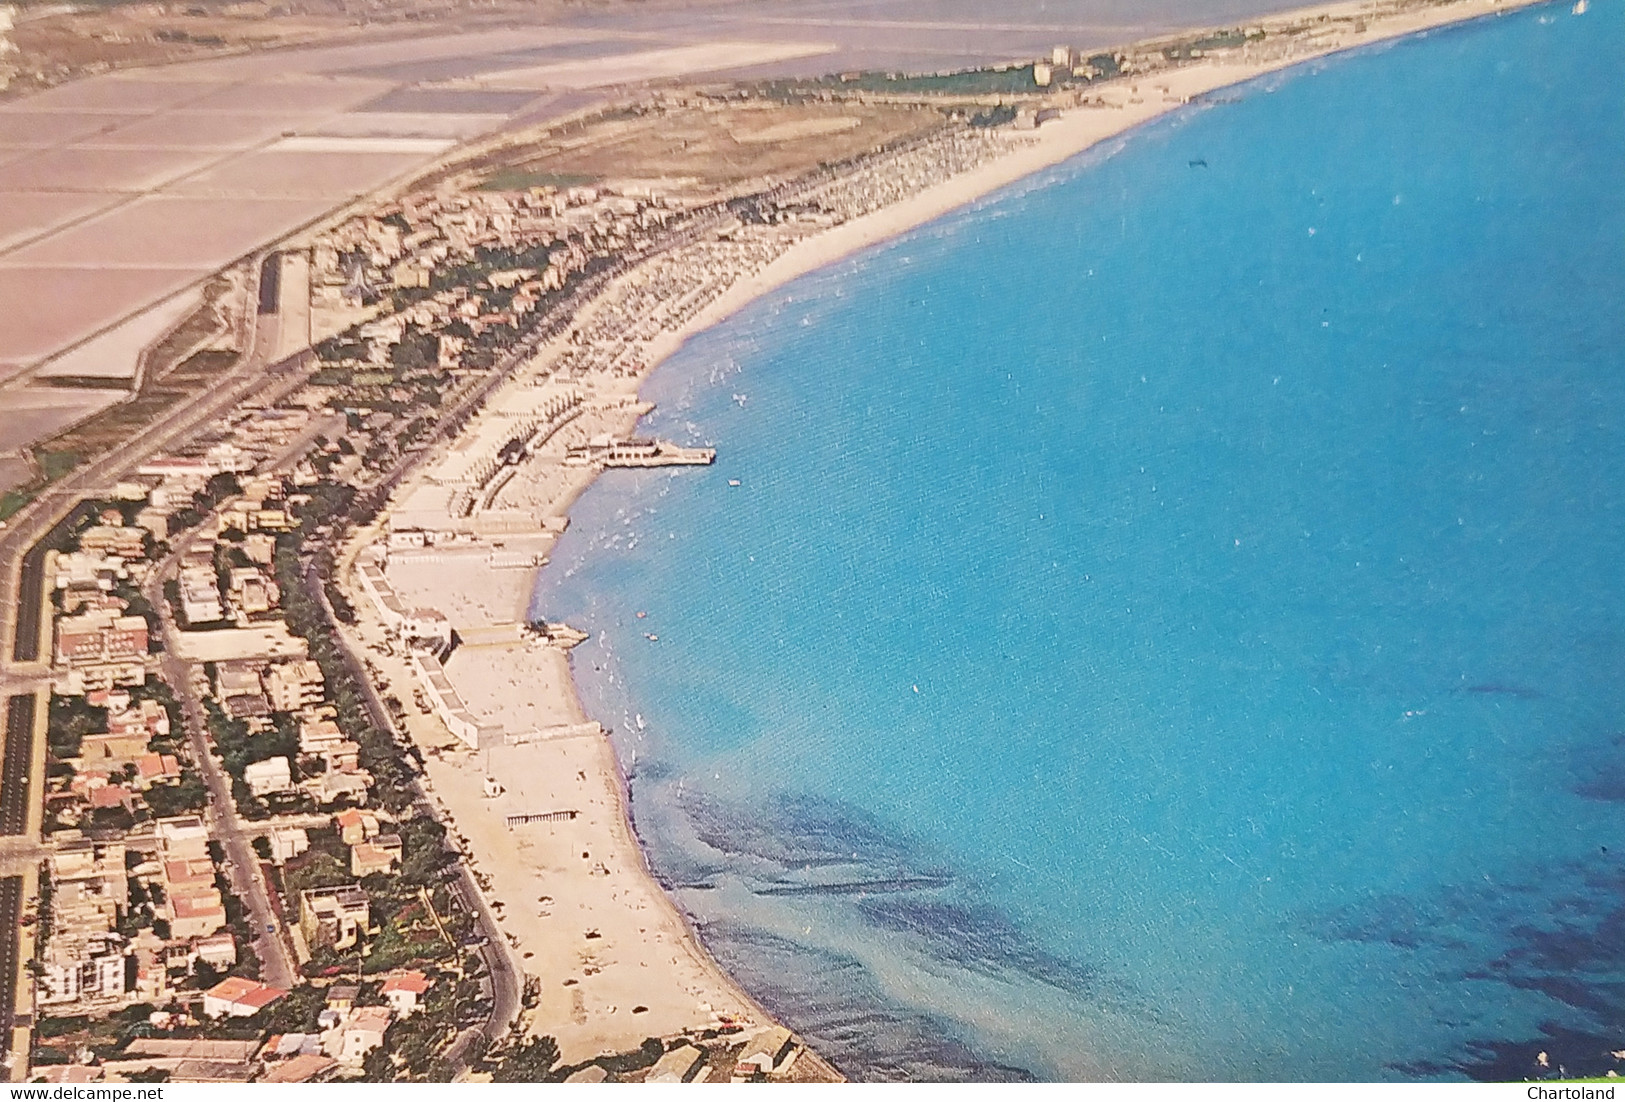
326;0;1524;1079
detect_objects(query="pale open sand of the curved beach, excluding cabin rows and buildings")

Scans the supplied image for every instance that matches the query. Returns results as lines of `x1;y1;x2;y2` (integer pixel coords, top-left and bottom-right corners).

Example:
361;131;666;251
343;0;1528;1079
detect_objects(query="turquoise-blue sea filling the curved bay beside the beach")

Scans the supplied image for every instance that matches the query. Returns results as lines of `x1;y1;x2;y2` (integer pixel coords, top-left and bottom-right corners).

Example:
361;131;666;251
536;0;1625;1079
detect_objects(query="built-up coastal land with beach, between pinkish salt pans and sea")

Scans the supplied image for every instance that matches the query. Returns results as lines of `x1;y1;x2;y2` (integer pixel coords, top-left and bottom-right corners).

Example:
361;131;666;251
0;0;1547;1081
